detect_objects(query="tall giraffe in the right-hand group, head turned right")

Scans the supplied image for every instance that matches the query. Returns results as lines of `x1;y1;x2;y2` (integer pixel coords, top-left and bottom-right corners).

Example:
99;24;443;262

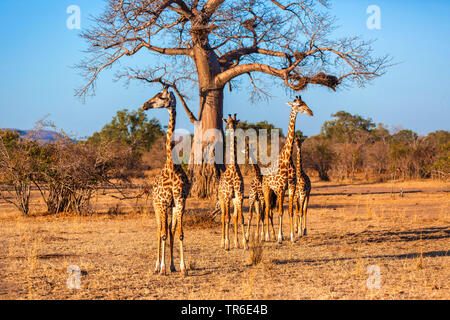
263;96;313;243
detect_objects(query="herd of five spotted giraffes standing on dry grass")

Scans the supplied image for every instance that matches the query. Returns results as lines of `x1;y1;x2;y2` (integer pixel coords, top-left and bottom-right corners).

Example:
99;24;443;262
142;87;313;276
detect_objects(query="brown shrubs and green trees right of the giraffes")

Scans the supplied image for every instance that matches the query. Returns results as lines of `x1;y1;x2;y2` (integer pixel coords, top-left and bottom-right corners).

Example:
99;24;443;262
303;111;450;181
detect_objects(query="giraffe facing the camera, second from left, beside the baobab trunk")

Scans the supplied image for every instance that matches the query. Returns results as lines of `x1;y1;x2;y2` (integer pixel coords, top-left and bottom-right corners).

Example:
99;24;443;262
218;114;248;250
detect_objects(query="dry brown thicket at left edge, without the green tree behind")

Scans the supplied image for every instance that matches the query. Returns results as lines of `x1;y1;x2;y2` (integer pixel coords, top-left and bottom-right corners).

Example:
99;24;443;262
0;126;143;215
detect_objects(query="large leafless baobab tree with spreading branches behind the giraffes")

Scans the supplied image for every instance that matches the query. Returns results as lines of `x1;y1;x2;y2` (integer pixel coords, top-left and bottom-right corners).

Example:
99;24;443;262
76;0;390;197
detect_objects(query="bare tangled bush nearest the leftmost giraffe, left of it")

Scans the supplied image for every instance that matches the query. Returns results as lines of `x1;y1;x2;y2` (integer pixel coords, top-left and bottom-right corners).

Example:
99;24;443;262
34;138;138;214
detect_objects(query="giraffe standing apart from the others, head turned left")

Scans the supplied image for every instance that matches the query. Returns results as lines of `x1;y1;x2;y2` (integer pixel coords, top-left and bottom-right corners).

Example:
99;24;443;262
142;87;190;276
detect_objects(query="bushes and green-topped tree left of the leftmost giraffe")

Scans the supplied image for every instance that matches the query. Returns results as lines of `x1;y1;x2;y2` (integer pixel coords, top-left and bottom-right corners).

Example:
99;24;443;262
0;110;163;215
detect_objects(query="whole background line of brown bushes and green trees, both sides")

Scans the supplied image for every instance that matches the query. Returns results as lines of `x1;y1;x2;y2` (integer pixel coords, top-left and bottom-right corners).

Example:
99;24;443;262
0;110;450;215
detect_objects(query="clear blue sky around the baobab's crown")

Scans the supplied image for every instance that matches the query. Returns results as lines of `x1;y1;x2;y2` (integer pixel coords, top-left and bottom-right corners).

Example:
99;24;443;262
0;0;450;137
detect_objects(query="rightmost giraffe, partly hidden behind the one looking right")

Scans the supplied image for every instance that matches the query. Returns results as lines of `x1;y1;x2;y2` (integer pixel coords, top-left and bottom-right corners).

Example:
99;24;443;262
294;137;311;236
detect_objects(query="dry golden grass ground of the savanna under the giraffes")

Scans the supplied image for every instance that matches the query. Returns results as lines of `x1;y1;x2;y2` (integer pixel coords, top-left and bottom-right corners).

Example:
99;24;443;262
0;181;450;299
